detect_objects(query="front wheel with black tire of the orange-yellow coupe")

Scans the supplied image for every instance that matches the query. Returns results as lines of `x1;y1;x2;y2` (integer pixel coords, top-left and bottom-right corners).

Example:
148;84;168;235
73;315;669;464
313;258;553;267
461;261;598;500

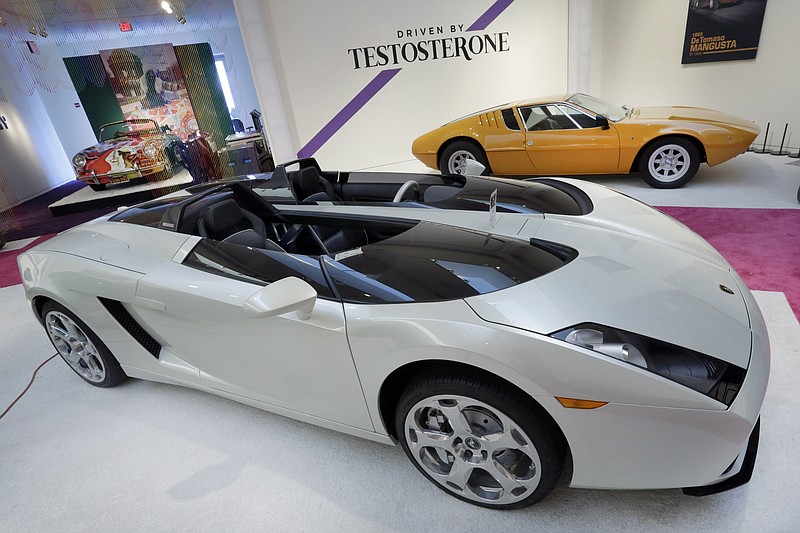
639;137;700;189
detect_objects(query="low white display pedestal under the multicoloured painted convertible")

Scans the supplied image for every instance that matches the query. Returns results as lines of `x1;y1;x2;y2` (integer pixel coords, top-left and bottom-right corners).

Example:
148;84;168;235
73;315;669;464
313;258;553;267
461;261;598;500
47;168;194;217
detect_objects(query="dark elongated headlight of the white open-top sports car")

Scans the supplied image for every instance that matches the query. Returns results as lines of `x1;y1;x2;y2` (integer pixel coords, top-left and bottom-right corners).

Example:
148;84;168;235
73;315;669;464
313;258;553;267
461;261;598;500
551;324;746;406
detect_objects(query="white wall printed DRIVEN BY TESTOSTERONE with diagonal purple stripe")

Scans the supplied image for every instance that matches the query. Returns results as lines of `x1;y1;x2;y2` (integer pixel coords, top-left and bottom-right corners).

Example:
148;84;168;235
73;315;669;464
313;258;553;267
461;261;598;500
247;0;568;169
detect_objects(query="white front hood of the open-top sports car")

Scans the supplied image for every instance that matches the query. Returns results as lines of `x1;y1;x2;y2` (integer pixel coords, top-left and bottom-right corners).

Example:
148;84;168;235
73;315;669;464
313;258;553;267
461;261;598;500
467;179;751;368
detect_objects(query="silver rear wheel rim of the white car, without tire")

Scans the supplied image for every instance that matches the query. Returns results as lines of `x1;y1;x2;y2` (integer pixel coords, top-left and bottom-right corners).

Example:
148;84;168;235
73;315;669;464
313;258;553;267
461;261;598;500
45;311;106;383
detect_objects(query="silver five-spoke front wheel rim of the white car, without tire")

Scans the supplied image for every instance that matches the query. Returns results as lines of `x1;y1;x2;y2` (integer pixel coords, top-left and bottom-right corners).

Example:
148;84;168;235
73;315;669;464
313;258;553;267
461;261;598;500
405;394;542;506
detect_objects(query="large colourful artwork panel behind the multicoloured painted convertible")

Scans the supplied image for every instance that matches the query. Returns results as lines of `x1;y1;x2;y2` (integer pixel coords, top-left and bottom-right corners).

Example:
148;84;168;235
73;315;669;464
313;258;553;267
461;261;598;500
100;44;198;139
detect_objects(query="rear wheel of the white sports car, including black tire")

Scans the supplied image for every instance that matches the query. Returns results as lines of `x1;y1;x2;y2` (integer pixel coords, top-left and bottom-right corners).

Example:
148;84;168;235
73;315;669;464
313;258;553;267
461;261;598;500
42;301;128;388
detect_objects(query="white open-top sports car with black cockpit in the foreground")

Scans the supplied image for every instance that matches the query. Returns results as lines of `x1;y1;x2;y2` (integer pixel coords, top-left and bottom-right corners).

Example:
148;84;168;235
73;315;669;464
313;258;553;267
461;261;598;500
19;162;769;509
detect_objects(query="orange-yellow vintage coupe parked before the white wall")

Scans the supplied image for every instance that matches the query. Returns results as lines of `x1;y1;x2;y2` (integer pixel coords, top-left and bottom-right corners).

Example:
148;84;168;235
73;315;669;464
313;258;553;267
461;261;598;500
411;93;761;189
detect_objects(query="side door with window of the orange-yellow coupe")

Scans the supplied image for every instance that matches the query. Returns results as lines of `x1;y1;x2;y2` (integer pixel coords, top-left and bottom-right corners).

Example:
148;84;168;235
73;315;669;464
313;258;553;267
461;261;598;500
519;104;619;175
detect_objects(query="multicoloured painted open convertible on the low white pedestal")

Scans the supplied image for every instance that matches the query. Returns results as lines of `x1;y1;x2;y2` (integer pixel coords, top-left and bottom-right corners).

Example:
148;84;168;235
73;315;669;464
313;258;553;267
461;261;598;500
72;119;178;191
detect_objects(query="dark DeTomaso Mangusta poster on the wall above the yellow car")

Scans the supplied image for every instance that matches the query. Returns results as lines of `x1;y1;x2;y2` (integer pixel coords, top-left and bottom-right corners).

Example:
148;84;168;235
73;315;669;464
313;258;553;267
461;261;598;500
681;0;767;65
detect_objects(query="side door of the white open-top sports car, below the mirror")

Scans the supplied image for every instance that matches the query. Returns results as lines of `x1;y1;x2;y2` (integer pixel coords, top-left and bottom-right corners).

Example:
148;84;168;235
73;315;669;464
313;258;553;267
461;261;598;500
137;239;373;431
